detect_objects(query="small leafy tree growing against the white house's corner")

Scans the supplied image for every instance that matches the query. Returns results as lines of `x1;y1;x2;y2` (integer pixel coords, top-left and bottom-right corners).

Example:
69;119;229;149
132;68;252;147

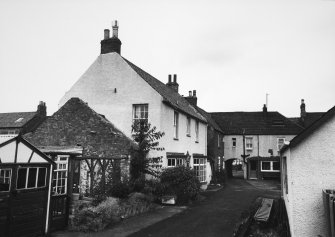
130;120;164;181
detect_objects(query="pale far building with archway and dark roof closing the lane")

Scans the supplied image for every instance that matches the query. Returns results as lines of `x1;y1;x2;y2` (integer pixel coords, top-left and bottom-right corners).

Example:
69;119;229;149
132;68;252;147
210;105;302;179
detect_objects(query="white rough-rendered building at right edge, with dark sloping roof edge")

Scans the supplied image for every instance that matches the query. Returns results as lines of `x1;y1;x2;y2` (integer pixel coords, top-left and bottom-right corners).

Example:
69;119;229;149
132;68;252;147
281;107;335;237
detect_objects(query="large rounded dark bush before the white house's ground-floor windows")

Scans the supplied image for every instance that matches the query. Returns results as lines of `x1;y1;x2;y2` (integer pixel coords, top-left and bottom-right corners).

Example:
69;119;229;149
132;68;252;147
161;166;200;204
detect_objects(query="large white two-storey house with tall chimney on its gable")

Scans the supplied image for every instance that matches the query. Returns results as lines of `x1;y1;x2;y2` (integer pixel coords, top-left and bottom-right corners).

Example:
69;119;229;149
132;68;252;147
59;22;211;184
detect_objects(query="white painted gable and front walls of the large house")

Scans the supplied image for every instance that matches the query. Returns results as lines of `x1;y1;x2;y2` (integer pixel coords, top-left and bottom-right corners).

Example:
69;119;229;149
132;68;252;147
59;53;211;181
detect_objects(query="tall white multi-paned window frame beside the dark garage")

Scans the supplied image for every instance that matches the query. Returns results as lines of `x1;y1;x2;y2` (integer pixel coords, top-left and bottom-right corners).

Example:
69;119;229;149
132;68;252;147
52;155;69;196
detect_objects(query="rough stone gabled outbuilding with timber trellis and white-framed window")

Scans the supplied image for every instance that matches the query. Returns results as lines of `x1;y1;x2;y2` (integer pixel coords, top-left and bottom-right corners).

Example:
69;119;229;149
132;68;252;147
25;98;133;230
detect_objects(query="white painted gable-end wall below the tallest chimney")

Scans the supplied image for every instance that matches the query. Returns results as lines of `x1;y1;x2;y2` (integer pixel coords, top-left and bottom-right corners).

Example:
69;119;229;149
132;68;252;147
59;53;162;137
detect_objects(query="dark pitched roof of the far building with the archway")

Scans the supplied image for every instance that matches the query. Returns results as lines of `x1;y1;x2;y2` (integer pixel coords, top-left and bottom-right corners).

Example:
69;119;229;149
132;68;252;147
210;112;302;135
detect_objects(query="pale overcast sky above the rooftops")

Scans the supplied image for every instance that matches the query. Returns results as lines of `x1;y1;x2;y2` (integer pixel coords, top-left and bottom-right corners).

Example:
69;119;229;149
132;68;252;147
0;0;335;116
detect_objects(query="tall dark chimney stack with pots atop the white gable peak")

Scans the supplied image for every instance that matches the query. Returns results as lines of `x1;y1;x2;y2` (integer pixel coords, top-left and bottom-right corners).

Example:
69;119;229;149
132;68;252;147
100;21;122;54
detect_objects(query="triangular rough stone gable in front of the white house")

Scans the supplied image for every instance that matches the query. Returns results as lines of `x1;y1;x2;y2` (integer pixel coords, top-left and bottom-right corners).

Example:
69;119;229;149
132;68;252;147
25;98;136;158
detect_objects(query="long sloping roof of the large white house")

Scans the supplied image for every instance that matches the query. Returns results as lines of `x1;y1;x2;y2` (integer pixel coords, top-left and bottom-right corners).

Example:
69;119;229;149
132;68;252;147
122;57;207;123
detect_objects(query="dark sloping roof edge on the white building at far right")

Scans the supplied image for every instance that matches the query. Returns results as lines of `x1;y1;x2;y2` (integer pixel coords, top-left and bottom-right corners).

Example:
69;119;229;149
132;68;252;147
280;106;335;153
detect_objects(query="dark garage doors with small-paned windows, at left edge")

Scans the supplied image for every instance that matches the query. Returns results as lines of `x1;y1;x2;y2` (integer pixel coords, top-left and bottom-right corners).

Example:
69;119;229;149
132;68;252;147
0;164;50;237
